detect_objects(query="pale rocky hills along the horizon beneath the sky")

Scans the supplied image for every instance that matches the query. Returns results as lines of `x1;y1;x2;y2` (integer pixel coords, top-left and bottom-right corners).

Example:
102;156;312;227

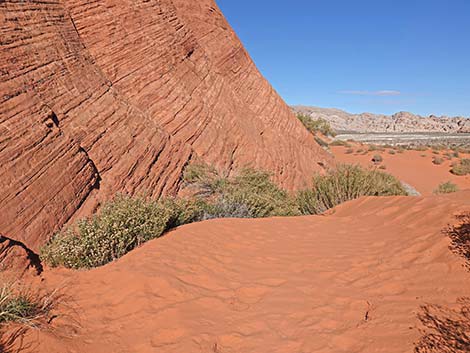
292;106;470;133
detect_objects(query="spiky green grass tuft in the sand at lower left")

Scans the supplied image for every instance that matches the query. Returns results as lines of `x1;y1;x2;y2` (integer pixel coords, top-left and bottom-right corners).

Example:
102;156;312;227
0;283;56;326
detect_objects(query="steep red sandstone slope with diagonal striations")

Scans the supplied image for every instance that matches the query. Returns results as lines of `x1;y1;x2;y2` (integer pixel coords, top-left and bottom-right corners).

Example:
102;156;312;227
0;0;329;251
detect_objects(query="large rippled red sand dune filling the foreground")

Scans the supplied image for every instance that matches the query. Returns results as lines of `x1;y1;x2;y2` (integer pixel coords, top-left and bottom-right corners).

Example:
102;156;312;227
14;192;470;353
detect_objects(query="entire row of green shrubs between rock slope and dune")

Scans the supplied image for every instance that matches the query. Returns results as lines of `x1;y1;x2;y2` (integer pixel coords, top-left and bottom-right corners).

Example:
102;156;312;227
41;164;406;269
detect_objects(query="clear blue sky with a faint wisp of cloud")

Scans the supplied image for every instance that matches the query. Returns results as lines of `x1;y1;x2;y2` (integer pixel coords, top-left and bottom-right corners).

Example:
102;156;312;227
216;0;470;116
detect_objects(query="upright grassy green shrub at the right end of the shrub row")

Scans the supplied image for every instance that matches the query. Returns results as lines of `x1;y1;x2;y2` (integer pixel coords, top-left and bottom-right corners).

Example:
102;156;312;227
297;164;406;214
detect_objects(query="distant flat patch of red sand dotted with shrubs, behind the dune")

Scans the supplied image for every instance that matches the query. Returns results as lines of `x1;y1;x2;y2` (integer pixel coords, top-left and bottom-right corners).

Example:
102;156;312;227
332;145;470;195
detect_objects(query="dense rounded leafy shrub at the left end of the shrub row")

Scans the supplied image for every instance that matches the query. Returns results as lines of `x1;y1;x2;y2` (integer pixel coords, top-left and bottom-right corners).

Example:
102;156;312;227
41;195;178;269
